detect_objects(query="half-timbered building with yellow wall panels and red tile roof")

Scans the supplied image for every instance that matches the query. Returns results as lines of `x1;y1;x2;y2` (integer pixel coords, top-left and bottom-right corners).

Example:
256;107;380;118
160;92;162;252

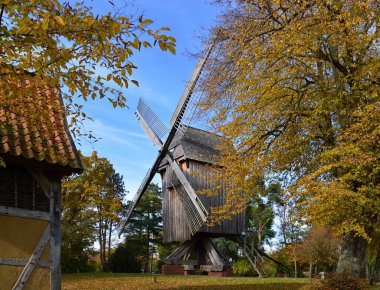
0;81;82;290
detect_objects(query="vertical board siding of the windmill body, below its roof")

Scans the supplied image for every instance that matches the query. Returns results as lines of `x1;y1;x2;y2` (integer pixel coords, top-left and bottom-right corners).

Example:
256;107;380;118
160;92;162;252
162;160;245;242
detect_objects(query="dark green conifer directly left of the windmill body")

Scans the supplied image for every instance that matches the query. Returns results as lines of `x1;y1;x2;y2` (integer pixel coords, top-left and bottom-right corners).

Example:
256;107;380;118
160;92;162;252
125;183;162;273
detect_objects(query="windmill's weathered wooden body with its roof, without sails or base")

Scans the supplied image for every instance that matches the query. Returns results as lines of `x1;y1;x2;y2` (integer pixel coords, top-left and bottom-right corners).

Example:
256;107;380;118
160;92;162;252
159;127;244;242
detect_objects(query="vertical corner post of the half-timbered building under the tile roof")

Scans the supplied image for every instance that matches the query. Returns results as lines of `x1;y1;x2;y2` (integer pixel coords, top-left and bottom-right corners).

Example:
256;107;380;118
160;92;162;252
50;181;61;290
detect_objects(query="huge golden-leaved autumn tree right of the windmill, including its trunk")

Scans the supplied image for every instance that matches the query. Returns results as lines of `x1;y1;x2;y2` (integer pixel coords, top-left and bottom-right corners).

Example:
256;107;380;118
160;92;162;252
199;0;380;276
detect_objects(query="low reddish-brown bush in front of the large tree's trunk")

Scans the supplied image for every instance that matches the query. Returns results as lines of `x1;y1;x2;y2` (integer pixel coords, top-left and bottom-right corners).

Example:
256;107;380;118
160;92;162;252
318;273;368;290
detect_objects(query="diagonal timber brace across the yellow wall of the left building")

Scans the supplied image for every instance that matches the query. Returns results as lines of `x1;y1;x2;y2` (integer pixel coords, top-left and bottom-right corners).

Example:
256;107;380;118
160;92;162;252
12;224;50;290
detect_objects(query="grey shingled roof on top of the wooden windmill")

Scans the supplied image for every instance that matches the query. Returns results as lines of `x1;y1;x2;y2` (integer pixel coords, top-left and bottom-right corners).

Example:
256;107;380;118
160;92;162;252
161;126;222;166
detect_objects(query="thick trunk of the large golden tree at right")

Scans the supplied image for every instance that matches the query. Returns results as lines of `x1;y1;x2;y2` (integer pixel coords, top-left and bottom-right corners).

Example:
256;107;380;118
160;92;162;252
336;233;368;278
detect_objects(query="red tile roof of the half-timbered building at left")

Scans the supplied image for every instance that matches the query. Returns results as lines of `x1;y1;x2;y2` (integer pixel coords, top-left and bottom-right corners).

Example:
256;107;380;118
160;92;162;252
0;81;82;172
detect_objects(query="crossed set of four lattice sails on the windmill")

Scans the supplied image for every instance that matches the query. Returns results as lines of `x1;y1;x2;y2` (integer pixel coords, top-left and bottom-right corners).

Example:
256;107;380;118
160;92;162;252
119;42;214;236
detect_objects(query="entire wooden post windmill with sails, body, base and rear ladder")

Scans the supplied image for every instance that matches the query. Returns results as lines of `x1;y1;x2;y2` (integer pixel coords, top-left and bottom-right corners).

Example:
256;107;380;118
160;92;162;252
119;40;280;276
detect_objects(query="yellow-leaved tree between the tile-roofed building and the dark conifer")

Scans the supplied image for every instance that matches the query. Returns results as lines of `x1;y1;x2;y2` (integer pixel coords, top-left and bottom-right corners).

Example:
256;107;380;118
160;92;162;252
62;151;125;271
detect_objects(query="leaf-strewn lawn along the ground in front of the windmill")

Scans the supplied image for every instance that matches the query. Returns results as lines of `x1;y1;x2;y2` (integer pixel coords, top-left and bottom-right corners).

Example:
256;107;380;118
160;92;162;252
62;273;311;290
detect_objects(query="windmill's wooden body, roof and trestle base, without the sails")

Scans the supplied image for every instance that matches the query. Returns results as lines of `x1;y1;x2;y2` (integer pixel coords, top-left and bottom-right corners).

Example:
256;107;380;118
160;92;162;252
159;127;245;276
